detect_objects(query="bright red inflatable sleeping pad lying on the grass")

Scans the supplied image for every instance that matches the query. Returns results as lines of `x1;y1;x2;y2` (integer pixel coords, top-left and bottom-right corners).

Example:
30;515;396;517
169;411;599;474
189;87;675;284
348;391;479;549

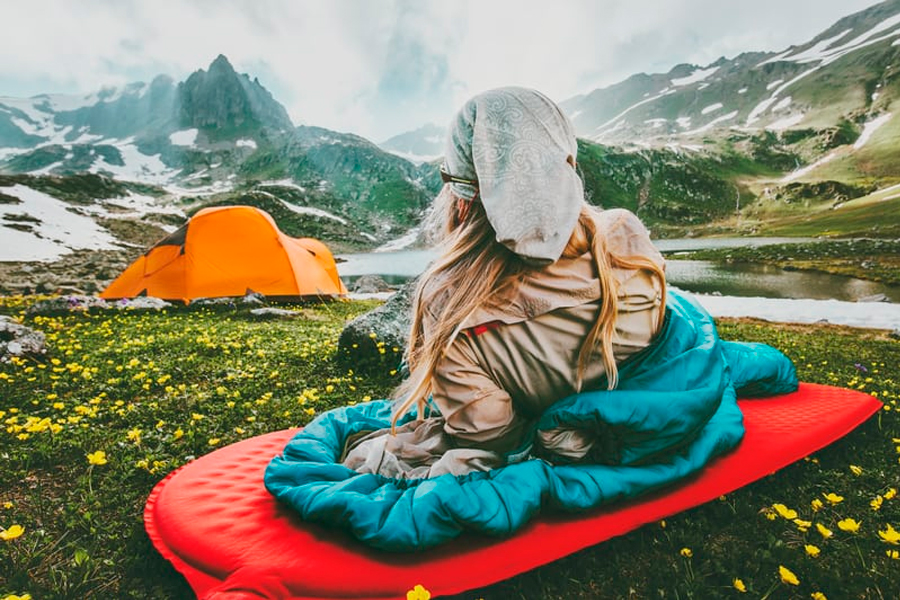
144;384;881;600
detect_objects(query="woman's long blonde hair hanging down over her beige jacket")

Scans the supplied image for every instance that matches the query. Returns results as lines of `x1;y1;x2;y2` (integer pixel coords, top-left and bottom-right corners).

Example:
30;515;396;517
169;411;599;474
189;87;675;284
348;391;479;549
391;185;665;431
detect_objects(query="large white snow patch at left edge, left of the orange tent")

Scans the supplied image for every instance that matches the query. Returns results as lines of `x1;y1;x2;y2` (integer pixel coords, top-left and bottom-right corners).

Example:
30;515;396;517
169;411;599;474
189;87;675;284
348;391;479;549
0;184;117;261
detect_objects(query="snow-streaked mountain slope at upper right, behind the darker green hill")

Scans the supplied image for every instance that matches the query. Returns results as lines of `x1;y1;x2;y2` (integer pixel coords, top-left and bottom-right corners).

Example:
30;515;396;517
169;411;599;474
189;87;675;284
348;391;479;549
562;0;900;144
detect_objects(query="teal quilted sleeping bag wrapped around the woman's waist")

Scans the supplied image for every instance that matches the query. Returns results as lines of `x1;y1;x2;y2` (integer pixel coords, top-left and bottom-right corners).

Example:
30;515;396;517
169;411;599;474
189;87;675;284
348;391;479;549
265;289;797;551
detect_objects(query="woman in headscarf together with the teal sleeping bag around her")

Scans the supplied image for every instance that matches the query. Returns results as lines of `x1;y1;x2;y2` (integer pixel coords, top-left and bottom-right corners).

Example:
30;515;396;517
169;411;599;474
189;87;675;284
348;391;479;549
265;88;797;552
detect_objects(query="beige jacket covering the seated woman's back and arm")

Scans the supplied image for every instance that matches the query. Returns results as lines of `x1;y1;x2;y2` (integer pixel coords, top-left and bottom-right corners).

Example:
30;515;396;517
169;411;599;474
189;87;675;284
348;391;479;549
425;210;663;449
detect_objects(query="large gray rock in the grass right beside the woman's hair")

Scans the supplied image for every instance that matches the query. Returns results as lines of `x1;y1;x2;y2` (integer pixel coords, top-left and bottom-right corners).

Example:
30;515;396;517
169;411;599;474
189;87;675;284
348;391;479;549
338;280;416;368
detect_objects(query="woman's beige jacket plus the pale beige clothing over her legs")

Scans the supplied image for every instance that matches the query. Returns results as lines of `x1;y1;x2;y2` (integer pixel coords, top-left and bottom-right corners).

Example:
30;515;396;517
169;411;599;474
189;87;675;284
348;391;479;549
345;209;664;477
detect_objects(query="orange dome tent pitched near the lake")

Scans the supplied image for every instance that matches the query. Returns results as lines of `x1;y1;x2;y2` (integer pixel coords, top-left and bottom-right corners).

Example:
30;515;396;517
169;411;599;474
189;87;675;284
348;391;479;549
100;206;347;303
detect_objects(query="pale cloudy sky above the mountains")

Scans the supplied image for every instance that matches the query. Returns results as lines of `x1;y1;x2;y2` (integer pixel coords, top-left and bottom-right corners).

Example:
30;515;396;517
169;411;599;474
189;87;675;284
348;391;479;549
0;0;877;142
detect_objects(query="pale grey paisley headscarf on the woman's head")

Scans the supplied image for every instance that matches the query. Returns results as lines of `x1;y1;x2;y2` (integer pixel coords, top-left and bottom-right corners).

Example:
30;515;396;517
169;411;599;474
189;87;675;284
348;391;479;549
444;87;584;264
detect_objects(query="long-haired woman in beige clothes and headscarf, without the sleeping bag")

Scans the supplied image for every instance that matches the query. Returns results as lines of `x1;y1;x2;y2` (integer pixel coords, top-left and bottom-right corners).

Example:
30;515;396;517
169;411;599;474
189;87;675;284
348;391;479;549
344;87;665;478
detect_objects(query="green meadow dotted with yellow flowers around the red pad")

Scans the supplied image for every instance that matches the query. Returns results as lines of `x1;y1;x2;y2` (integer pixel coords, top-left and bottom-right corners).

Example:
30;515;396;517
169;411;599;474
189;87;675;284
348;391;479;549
0;297;900;600
